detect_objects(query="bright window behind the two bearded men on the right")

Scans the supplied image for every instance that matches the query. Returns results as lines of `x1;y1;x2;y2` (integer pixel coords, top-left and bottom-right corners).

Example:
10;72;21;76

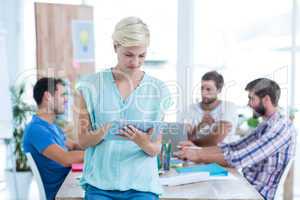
193;0;292;107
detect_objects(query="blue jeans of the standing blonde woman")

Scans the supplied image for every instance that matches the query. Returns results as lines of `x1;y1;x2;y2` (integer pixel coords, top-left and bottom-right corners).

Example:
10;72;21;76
84;185;159;200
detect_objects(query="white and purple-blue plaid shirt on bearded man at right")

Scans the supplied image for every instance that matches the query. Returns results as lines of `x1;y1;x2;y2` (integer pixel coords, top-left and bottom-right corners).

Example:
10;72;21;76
219;112;296;200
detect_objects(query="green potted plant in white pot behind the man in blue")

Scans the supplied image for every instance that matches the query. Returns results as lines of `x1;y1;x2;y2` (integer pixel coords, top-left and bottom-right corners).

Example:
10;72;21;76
10;83;35;199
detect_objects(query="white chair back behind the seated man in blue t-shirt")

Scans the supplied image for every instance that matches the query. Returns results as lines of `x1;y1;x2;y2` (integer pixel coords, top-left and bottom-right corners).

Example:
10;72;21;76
26;153;47;200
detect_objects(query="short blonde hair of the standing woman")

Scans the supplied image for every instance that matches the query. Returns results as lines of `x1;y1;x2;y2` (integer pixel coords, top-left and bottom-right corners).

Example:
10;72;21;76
112;17;150;47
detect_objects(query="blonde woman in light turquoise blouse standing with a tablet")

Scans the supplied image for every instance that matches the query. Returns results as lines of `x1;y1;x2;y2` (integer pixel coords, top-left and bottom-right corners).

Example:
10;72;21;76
77;17;170;200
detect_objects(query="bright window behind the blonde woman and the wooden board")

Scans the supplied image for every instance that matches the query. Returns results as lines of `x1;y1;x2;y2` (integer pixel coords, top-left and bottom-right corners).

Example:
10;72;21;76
24;0;177;121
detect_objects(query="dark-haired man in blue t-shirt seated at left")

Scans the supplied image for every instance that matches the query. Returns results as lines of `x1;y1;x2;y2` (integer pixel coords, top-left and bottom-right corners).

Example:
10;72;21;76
23;78;83;200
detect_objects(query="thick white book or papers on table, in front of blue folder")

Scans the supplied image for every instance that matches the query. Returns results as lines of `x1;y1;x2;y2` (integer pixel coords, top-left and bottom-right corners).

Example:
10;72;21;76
159;172;209;186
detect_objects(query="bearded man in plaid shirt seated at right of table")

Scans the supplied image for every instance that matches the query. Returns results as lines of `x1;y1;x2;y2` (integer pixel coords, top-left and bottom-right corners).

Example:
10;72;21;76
175;78;296;200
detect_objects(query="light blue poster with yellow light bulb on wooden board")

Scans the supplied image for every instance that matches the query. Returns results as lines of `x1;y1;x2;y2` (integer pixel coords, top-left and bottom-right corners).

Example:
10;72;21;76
72;20;95;63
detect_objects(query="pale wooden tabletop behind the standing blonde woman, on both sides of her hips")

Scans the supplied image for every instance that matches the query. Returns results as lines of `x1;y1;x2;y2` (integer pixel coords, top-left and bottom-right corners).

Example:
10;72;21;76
56;169;263;200
